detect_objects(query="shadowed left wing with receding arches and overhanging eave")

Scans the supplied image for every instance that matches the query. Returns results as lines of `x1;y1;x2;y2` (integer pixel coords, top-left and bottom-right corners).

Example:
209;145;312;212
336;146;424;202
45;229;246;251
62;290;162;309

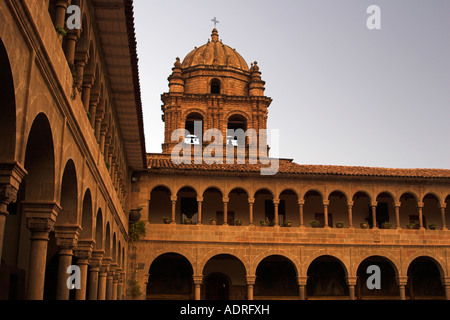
0;0;146;300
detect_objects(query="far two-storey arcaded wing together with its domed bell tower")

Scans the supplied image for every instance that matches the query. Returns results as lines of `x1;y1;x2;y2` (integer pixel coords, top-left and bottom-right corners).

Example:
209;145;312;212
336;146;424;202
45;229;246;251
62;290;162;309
130;29;450;300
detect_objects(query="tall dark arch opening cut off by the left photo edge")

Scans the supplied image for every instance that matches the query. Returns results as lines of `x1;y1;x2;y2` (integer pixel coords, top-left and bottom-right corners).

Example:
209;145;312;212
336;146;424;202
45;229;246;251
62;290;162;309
0;39;16;162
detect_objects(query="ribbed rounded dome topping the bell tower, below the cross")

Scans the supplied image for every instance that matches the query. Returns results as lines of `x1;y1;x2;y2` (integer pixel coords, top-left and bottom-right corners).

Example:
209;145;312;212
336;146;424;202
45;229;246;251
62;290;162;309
181;28;249;71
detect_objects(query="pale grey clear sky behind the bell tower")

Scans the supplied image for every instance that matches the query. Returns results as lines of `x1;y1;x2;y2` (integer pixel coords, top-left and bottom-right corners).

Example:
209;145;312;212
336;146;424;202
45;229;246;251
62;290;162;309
134;0;450;169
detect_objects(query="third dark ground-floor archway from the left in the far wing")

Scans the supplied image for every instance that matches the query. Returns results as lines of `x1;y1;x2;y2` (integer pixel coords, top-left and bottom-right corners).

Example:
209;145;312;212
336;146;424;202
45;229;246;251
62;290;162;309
254;255;299;300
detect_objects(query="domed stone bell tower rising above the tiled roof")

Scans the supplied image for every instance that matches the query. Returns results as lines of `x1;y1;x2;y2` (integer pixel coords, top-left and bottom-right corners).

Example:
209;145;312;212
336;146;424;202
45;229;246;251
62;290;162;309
161;28;272;161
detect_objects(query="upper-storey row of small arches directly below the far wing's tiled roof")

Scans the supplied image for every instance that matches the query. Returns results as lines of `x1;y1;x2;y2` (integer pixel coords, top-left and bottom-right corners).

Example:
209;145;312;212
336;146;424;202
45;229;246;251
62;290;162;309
148;185;450;230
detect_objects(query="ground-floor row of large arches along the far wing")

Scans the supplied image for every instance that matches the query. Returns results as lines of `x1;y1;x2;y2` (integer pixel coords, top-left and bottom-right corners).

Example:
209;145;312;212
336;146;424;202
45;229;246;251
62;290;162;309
144;251;450;300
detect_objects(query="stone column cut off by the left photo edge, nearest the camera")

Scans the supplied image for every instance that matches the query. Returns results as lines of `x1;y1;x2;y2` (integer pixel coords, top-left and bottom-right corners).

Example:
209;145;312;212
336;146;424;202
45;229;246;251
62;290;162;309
0;162;27;266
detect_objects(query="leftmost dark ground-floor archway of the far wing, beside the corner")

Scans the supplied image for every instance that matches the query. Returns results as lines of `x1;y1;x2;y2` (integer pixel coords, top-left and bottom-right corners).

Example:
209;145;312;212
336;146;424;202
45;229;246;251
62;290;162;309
147;253;193;300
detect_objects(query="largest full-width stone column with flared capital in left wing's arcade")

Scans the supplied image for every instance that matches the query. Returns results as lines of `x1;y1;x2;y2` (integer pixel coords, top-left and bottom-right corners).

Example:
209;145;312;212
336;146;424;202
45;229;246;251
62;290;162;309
22;202;61;300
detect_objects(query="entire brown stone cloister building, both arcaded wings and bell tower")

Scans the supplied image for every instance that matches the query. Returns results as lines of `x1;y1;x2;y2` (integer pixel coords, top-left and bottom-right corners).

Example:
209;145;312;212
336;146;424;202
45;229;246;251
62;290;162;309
0;0;450;300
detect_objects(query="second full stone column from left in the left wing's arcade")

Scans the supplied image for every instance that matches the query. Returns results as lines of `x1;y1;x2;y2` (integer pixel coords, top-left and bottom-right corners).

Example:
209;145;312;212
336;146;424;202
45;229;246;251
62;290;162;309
55;226;80;300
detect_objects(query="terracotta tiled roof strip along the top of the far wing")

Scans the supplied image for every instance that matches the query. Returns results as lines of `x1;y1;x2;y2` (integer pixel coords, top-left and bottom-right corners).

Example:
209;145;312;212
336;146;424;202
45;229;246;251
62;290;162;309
147;154;450;179
